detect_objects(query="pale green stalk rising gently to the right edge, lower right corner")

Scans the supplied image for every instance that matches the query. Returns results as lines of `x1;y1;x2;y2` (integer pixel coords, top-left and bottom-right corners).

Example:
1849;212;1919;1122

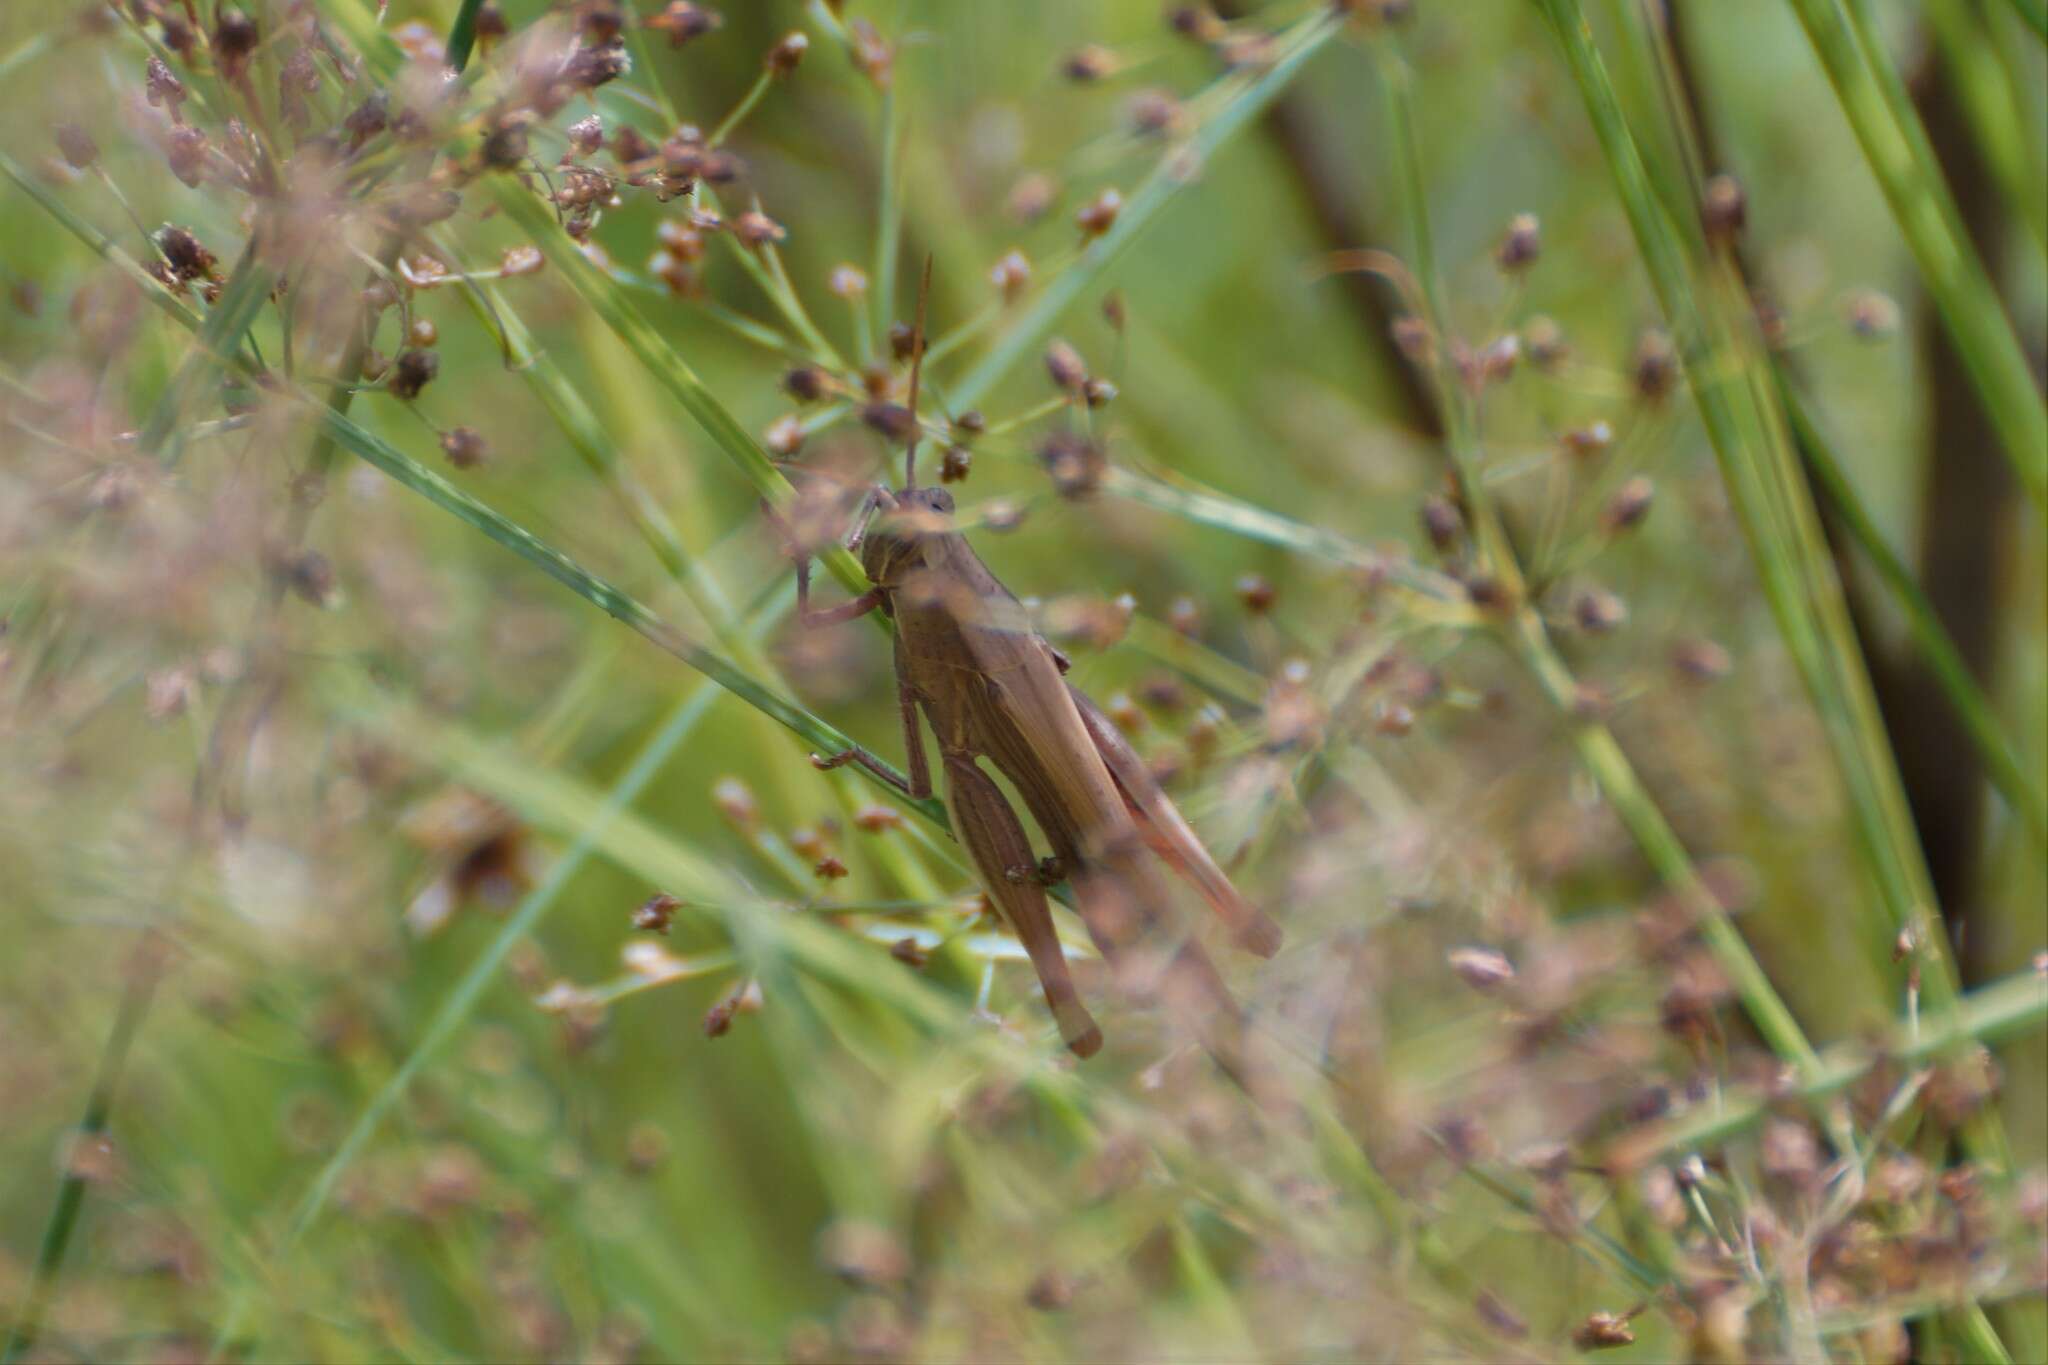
1602;970;2048;1171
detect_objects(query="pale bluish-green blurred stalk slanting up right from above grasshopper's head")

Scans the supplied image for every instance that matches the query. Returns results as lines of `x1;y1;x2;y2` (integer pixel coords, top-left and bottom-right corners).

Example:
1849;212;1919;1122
950;6;1343;407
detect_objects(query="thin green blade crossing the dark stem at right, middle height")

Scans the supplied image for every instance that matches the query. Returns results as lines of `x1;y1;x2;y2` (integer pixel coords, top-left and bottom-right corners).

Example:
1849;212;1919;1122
1778;370;2048;849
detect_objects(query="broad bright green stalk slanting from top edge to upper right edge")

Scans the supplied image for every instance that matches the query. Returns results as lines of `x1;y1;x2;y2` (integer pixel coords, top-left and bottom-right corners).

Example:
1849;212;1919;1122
1777;0;2048;512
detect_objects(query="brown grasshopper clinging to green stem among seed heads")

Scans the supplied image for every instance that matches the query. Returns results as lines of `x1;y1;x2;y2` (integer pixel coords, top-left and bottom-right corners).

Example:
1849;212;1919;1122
784;270;1280;1072
